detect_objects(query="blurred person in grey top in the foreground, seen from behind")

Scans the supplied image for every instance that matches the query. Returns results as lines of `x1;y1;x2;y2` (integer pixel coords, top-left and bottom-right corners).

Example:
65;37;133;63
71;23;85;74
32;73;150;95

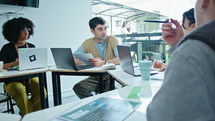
147;0;215;121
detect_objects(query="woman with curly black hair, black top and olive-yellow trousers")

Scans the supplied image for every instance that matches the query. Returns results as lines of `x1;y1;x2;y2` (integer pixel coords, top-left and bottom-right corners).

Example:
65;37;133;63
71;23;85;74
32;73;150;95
0;17;46;116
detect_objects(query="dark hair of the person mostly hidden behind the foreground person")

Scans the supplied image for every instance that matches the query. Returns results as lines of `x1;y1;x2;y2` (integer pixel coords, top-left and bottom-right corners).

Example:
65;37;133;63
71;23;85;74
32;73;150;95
182;8;196;29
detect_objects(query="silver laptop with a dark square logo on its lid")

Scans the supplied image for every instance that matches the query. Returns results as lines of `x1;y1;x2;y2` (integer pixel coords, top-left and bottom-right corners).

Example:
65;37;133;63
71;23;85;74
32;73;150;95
18;48;48;70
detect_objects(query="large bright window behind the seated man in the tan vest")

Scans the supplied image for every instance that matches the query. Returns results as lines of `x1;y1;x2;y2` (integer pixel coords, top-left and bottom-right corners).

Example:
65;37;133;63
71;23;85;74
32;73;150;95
92;0;195;61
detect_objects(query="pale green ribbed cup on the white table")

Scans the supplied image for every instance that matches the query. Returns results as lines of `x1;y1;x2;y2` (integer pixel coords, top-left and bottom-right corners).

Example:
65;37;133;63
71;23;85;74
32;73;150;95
139;60;152;81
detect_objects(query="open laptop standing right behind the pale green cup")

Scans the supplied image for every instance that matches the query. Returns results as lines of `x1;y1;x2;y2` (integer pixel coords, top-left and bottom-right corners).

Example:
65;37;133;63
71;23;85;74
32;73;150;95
117;45;140;76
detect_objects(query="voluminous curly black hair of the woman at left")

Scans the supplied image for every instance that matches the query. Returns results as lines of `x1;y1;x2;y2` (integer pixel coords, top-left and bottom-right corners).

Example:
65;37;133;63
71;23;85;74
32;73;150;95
2;17;35;42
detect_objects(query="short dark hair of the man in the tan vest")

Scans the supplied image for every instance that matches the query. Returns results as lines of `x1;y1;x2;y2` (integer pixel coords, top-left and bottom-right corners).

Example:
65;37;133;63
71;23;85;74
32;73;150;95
89;17;106;30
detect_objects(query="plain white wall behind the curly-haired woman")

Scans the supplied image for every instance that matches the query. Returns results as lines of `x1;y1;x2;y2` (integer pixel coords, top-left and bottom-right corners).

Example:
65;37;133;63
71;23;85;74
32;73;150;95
0;0;92;97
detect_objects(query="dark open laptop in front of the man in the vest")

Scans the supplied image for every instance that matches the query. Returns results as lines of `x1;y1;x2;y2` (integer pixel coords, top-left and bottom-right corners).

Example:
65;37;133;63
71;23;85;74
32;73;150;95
51;48;94;70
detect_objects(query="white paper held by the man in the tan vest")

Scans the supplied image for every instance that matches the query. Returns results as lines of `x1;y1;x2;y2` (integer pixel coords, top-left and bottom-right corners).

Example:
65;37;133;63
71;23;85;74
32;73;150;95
74;53;94;65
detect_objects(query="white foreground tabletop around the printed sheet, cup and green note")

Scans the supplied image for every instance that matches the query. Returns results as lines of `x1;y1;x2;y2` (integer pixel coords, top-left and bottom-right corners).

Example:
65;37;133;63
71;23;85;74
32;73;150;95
23;66;164;121
